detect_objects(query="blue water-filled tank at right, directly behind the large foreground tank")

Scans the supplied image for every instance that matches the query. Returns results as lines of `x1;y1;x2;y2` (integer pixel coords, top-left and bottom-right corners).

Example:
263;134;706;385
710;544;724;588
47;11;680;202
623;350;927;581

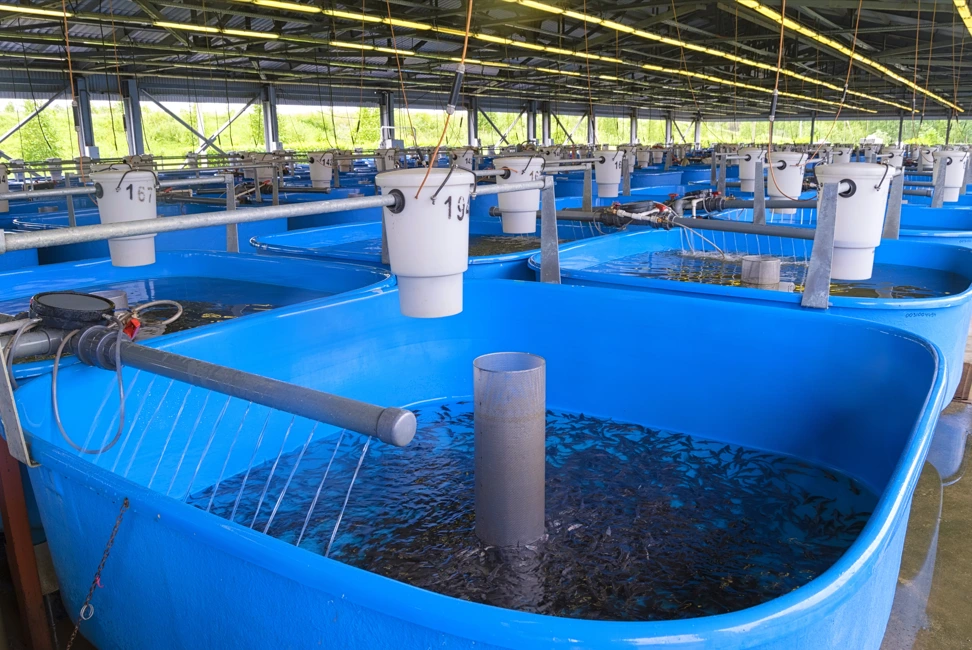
530;228;972;395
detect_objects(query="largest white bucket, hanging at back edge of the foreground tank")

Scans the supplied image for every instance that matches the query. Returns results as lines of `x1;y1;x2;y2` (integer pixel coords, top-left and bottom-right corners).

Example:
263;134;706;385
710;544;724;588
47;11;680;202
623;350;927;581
375;168;474;318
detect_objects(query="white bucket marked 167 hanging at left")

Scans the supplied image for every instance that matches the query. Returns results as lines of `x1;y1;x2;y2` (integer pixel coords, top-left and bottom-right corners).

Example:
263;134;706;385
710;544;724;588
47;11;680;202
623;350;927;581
91;171;156;266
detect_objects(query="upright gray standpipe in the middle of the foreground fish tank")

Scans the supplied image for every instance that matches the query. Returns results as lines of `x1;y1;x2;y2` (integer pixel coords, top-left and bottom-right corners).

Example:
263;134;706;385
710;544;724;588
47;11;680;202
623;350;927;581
473;352;546;546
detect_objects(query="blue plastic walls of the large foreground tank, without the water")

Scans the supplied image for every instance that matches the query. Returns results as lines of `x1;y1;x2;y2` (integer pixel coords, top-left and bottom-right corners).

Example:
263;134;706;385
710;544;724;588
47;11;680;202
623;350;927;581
7;281;945;650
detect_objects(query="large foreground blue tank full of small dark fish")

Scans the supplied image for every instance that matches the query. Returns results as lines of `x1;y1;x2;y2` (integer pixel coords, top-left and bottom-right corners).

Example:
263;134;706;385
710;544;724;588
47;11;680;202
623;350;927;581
7;281;945;650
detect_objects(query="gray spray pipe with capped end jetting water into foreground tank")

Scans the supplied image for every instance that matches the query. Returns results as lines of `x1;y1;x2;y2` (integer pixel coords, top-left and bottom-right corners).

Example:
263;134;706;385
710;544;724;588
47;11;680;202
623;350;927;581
72;327;416;447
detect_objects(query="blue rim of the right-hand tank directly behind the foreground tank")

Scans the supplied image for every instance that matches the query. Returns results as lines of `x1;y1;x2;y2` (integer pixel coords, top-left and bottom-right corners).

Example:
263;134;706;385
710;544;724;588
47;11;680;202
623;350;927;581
527;230;972;310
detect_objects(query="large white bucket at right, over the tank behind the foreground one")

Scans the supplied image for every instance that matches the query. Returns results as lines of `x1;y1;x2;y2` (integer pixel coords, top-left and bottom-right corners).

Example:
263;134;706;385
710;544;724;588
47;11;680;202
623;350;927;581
816;163;893;280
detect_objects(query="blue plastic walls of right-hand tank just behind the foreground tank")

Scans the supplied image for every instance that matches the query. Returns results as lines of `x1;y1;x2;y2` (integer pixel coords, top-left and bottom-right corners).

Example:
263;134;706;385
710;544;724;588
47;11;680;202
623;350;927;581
530;229;972;395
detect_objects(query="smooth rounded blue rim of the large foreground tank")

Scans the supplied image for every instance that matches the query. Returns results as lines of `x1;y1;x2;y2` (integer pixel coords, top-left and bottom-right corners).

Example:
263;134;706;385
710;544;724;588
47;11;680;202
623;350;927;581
13;280;946;648
